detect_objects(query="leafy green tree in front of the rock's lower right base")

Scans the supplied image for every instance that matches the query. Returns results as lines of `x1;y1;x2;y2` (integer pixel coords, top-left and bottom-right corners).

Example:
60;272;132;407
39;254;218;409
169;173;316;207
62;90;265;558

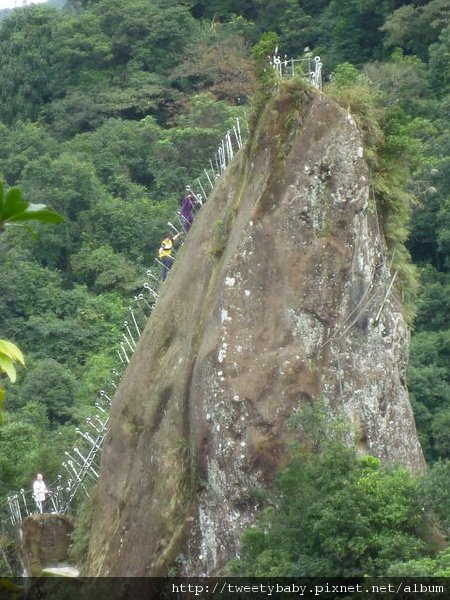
231;444;430;577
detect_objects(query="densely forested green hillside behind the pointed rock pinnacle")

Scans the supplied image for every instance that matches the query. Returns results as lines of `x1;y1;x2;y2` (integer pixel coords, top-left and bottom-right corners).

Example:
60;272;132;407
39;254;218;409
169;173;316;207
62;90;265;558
0;0;450;576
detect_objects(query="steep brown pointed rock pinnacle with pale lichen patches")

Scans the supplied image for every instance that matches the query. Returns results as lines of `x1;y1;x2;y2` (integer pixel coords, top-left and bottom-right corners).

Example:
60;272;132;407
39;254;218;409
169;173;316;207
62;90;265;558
85;83;424;576
